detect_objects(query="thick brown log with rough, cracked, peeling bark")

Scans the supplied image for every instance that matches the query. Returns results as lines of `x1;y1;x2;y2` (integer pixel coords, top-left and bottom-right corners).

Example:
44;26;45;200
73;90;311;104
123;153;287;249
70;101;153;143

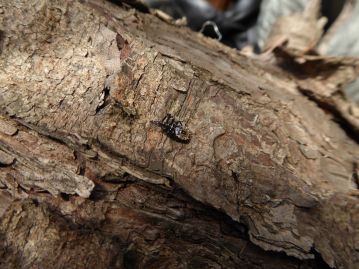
0;0;359;268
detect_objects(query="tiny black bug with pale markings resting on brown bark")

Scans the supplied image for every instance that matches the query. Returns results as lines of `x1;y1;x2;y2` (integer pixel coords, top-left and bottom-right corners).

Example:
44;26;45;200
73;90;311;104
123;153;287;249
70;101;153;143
151;114;191;144
